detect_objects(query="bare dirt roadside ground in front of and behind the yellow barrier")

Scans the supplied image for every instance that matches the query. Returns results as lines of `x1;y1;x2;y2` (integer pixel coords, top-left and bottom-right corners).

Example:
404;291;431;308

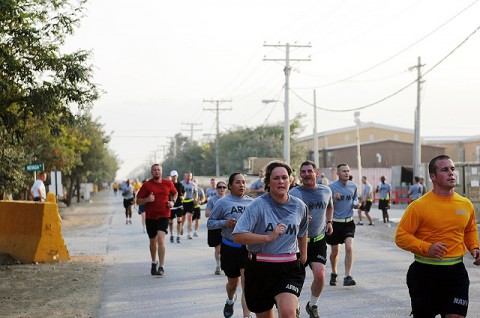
0;199;107;318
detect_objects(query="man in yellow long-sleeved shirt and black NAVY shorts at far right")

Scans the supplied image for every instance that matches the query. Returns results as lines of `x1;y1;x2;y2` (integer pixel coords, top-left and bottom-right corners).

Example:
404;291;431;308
395;155;480;318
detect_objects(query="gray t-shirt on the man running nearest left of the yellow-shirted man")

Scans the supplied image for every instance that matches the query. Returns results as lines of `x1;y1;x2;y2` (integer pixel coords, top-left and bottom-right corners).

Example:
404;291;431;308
328;180;358;219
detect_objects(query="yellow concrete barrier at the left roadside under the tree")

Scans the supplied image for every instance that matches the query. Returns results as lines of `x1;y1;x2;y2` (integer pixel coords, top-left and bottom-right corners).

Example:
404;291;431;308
0;201;70;263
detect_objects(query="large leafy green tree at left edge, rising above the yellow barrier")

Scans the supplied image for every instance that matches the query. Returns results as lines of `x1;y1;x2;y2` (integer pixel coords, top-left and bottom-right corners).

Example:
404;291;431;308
0;0;99;198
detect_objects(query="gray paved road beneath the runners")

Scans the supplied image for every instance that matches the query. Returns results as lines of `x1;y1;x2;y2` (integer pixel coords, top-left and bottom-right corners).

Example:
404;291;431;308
64;193;480;318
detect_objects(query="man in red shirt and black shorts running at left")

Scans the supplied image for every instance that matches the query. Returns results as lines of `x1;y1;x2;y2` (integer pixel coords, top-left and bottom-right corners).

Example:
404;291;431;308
137;163;178;276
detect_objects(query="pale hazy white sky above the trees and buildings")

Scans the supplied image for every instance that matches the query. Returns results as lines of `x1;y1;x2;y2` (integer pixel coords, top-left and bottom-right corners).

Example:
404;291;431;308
65;0;480;179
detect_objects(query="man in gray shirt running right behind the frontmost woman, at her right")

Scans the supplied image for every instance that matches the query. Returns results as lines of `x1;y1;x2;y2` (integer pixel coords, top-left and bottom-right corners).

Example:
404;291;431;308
289;161;333;317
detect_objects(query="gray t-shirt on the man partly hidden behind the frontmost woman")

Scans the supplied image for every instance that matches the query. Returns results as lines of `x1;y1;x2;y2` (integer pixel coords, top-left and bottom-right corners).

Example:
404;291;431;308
289;184;333;238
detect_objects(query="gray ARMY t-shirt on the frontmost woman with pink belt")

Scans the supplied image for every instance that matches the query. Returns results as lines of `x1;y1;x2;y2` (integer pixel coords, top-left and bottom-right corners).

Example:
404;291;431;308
233;193;308;254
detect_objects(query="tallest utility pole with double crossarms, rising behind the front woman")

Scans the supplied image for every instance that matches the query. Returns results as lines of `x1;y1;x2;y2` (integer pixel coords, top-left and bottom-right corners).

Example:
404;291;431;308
263;42;312;164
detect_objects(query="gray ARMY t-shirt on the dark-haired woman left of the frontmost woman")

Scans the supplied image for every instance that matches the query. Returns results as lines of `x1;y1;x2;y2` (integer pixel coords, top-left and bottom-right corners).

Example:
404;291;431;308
207;194;253;241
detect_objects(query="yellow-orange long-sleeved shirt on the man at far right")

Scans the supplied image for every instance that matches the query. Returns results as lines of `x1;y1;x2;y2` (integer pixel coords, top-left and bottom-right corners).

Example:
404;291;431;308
395;191;478;258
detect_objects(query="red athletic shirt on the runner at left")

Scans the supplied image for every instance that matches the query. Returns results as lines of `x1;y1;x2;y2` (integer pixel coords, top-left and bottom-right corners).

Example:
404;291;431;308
137;179;177;220
